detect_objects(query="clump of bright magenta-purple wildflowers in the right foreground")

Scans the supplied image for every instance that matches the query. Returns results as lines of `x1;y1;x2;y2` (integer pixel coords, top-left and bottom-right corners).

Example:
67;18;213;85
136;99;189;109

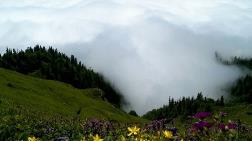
185;112;252;140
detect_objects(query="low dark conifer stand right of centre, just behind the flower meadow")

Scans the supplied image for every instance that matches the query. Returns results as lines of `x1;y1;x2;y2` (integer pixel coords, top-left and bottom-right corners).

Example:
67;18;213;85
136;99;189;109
143;93;224;120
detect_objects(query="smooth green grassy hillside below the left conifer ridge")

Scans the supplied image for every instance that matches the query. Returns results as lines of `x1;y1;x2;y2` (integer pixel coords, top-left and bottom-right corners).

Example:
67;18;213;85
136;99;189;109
0;68;138;122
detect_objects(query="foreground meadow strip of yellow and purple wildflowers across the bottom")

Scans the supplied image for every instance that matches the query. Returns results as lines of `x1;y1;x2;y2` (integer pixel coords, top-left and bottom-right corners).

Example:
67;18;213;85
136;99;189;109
0;112;252;141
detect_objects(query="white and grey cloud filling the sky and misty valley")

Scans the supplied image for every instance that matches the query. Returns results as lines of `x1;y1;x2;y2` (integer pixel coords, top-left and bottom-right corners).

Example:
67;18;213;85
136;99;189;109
0;0;252;114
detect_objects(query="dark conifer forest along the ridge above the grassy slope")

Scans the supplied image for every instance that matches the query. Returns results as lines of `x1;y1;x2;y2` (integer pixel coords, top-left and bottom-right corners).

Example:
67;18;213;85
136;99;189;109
0;45;123;107
